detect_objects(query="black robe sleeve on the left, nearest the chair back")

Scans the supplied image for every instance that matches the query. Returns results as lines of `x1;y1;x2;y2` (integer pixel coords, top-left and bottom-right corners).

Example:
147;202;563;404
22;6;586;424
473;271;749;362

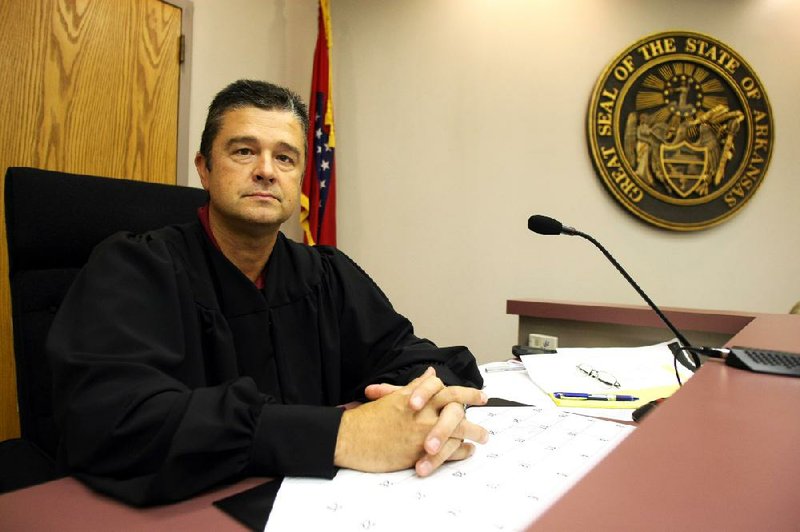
47;235;341;505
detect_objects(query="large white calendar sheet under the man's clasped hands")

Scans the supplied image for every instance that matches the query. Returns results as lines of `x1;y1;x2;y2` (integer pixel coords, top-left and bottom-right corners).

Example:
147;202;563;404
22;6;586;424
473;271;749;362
266;407;634;532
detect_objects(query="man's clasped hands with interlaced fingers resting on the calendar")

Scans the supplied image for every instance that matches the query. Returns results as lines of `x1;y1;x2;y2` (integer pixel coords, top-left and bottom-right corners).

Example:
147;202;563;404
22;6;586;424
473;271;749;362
334;370;487;476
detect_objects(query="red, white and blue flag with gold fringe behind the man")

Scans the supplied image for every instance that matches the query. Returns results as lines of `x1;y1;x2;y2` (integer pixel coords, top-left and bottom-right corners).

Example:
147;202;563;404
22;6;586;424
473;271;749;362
300;0;336;246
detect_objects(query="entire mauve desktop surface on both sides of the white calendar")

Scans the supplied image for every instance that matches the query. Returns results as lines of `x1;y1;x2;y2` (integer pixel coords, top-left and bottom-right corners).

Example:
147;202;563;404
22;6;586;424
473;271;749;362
0;305;800;531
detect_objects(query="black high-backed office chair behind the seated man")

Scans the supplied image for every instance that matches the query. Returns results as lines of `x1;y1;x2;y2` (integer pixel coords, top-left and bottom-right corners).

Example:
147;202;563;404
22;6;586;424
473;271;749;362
0;168;208;492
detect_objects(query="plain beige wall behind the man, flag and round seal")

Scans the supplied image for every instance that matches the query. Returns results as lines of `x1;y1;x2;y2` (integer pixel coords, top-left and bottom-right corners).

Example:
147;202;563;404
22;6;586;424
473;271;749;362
184;0;800;360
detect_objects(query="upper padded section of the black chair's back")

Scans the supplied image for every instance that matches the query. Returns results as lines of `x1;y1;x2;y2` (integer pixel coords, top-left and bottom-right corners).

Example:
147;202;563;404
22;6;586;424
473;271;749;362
5;167;208;275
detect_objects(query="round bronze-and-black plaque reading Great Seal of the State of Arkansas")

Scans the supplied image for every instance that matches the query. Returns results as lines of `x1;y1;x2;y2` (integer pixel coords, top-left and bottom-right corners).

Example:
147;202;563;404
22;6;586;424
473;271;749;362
588;32;773;231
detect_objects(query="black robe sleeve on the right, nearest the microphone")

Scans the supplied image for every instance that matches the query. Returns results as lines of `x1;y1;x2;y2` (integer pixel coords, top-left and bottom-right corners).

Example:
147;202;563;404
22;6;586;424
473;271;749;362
320;248;483;400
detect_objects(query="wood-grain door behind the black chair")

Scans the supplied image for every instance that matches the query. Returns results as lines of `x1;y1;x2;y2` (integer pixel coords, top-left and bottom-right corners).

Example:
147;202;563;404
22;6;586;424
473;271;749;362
0;0;181;440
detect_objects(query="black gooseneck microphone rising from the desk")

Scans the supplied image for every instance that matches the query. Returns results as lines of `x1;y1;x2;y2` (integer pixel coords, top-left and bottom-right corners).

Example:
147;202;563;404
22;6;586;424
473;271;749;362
528;214;704;371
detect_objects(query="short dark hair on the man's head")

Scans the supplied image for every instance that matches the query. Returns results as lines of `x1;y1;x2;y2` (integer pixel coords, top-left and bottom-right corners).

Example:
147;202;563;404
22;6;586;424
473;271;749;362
200;79;308;169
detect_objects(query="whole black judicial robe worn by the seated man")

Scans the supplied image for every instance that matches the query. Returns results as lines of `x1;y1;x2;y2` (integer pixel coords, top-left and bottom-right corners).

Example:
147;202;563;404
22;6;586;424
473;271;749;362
47;222;482;505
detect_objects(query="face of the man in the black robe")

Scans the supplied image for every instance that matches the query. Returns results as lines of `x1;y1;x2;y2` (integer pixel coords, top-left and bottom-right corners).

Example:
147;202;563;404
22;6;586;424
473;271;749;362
195;107;305;233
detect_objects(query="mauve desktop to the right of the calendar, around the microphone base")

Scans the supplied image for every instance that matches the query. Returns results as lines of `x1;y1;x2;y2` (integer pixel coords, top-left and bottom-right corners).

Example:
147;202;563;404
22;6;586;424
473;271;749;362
529;315;800;531
